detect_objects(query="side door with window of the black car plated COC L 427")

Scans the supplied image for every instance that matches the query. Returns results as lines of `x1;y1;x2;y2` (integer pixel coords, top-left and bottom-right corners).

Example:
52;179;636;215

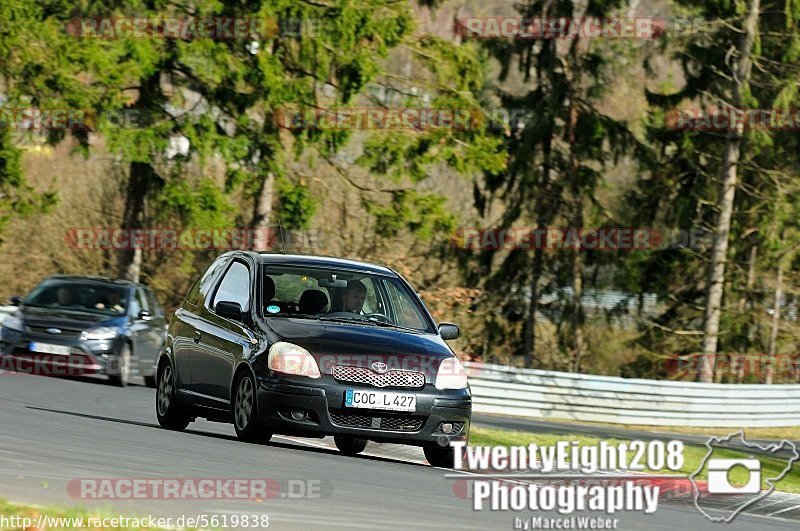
191;258;254;409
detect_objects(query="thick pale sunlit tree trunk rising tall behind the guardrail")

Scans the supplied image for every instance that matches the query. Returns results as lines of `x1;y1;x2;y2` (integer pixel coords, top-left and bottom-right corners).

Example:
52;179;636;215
700;0;760;382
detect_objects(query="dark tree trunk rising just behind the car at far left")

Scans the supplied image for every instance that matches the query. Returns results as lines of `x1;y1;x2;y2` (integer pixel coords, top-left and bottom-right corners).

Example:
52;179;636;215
119;162;155;282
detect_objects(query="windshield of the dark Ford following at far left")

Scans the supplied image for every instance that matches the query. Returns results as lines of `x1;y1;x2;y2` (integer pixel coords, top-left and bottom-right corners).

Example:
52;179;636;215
24;280;128;315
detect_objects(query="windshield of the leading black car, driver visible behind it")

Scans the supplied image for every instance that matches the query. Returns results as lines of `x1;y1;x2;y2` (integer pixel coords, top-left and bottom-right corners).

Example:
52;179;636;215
261;266;431;332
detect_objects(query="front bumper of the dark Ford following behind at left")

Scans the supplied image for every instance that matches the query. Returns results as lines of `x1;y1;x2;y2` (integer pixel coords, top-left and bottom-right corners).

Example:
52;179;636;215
0;327;124;376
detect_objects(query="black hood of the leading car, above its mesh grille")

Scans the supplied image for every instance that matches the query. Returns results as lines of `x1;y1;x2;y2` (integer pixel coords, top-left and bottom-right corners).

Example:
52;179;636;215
260;317;453;379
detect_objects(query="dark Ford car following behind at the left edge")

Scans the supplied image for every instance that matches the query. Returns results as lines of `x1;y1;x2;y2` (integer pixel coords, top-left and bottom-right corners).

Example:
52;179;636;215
0;276;166;387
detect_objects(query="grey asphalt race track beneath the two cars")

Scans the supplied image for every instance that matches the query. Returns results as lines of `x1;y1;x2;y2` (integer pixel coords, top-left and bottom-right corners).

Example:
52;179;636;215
0;374;800;531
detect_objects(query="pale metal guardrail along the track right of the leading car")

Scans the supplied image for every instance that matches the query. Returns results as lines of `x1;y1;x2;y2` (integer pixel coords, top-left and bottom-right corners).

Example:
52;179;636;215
464;362;800;428
